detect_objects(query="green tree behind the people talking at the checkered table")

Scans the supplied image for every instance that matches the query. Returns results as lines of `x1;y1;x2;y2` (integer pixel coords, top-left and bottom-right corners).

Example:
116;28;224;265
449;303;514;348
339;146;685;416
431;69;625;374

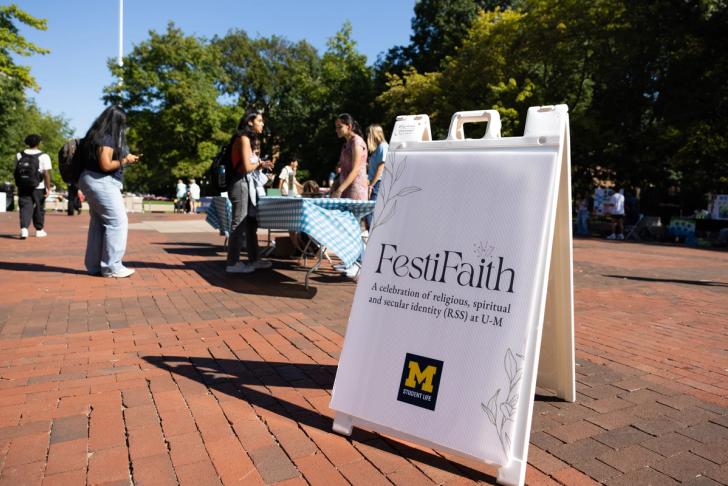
213;22;374;183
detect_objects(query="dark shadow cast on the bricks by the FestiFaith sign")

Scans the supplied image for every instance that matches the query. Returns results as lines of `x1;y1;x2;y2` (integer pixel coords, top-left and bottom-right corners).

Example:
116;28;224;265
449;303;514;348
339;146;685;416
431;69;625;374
148;356;496;484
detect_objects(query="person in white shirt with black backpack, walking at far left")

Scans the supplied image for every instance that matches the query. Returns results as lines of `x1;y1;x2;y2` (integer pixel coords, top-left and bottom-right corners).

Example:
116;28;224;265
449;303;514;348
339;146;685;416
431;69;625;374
14;134;52;239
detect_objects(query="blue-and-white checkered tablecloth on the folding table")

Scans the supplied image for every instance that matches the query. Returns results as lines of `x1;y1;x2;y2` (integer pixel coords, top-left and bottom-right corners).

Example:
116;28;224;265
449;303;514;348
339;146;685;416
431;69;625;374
206;196;374;266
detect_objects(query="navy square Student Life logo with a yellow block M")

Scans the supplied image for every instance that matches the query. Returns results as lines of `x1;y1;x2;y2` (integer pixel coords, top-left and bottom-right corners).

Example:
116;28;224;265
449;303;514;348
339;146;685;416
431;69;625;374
397;353;443;410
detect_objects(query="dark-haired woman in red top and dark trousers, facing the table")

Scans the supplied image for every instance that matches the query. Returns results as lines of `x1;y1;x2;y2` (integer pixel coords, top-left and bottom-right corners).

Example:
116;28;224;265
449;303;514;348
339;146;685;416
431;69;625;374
226;111;273;273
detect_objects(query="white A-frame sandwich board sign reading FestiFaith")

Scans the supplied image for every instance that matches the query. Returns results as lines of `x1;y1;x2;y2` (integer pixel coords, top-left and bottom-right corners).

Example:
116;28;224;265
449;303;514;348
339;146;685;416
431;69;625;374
331;105;575;484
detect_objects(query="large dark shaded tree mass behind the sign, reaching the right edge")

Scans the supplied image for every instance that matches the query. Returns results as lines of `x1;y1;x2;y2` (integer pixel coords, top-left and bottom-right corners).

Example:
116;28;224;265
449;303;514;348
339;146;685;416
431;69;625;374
378;0;728;214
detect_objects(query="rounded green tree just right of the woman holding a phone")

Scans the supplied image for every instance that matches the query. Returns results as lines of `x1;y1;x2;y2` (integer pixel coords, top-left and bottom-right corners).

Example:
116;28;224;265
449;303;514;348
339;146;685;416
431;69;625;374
104;23;232;194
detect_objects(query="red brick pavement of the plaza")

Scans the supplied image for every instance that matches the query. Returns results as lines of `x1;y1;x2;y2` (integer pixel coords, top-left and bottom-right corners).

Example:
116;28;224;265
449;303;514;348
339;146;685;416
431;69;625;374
0;213;728;485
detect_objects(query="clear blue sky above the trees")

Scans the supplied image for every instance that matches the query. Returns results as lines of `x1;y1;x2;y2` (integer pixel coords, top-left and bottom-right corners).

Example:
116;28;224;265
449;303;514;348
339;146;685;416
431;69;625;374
15;0;415;135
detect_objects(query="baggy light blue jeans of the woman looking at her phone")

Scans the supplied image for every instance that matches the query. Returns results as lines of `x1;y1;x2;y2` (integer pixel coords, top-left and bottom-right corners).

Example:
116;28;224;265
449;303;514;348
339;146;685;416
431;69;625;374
78;170;129;275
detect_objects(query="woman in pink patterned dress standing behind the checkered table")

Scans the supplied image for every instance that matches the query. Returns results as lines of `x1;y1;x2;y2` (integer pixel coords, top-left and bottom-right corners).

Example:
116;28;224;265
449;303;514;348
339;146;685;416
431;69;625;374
331;113;369;201
